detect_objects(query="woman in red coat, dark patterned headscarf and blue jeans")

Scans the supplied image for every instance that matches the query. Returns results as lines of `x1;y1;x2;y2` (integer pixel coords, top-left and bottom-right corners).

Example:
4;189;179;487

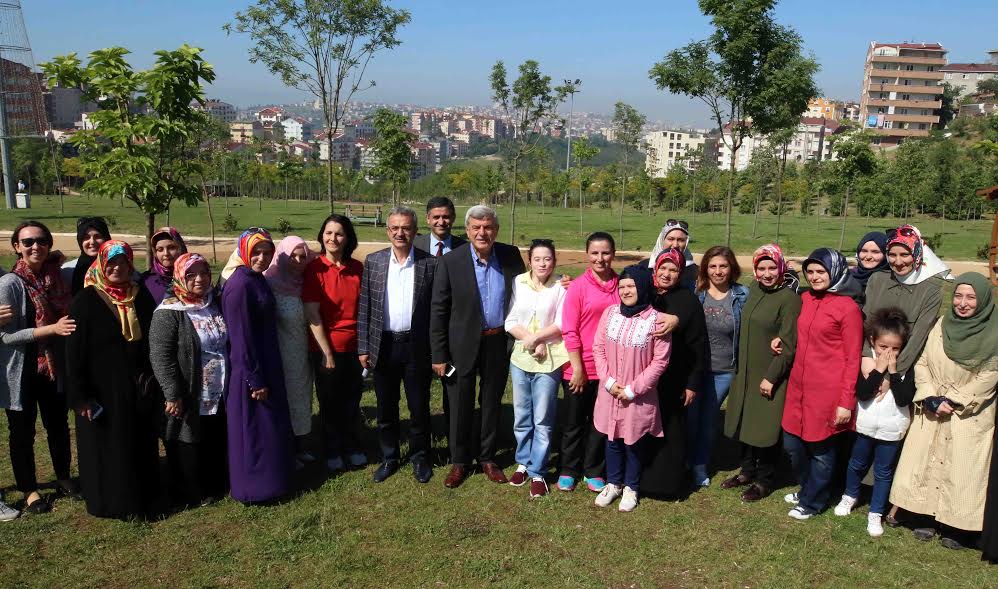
782;248;863;520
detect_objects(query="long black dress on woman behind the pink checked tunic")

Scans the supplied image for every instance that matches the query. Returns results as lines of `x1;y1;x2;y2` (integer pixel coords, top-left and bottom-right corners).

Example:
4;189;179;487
641;285;707;499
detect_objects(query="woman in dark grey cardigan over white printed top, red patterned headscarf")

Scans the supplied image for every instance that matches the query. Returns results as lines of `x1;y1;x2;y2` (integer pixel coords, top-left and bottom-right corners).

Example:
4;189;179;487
149;254;229;507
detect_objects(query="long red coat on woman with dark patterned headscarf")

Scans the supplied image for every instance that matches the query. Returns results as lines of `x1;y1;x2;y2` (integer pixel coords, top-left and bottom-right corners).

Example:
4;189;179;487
782;292;863;442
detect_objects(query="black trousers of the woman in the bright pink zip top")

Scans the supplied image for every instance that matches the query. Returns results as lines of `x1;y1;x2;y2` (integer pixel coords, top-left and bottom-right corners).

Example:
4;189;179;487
558;380;606;478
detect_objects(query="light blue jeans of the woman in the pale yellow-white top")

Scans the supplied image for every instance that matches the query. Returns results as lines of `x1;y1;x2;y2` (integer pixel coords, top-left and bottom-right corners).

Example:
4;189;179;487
509;364;561;477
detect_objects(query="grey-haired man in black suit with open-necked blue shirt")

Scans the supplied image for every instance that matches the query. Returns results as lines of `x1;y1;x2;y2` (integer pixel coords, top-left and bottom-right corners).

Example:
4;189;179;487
430;205;525;488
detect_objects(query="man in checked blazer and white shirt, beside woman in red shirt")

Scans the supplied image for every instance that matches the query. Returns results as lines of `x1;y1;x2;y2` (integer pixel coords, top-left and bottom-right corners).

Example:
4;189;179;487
357;207;436;483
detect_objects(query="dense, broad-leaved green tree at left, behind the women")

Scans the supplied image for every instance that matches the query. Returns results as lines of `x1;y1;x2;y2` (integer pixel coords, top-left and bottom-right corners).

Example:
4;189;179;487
42;44;215;260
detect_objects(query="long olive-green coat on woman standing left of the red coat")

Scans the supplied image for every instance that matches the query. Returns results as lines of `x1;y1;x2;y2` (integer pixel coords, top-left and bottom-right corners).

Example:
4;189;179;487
724;282;801;448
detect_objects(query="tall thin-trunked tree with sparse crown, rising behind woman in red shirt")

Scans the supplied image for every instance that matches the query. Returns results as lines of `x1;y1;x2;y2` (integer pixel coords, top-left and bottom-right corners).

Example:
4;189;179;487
223;0;411;213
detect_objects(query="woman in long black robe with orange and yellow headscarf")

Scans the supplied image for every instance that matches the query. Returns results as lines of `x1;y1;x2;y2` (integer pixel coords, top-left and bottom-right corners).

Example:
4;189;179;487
66;240;163;519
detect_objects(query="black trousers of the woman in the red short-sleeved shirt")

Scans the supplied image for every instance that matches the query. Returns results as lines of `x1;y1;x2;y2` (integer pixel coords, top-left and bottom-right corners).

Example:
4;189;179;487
312;352;364;458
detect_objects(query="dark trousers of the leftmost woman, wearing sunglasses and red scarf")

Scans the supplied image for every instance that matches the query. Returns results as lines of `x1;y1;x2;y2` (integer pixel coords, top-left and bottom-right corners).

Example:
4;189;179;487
7;372;72;493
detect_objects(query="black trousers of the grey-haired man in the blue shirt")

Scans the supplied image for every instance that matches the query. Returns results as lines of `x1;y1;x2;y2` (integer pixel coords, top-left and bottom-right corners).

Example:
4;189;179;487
448;333;509;465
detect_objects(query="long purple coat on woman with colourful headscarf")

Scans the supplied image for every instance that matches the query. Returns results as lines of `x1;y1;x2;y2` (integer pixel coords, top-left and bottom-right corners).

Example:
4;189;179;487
222;266;294;503
